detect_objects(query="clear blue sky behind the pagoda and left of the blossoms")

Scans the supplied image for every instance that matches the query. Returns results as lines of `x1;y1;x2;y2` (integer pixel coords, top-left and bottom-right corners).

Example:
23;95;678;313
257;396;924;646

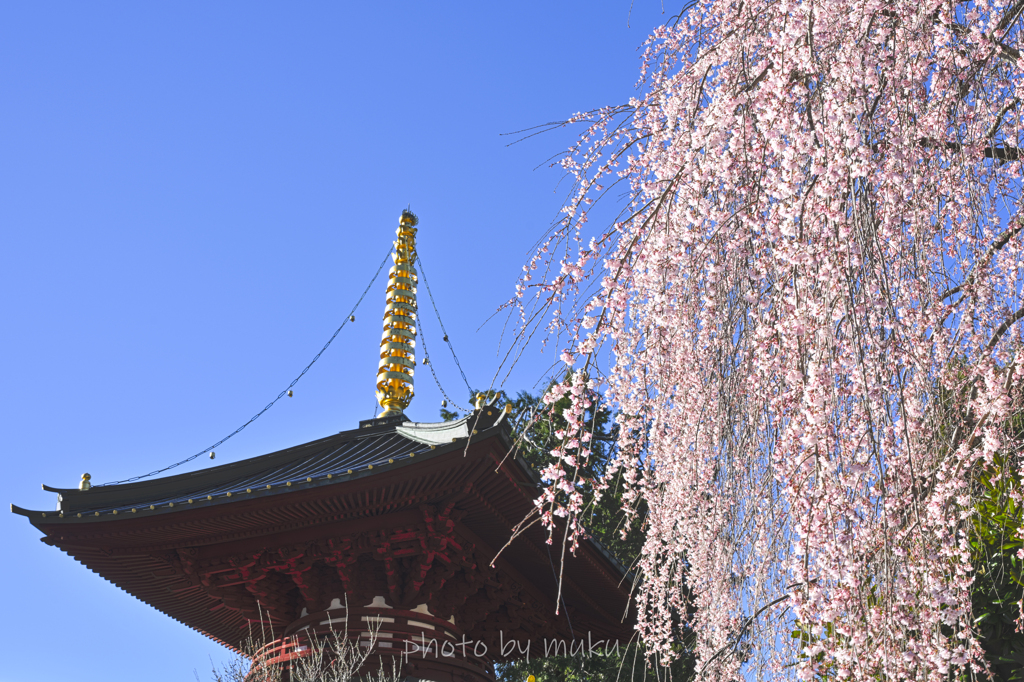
0;0;666;682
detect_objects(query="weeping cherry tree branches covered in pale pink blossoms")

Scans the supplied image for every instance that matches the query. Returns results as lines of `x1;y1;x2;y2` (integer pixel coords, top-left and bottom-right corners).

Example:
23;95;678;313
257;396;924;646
517;0;1024;682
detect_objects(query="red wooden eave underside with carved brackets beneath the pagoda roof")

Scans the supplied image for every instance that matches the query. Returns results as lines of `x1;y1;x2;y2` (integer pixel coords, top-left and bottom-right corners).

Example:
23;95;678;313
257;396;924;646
37;434;631;648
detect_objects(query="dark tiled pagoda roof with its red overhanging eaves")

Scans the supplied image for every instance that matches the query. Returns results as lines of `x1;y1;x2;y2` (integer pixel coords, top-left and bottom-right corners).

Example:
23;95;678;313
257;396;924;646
11;407;633;647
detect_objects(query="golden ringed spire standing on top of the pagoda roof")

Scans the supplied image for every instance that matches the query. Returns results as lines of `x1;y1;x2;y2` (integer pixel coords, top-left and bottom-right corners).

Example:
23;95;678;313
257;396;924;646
377;210;420;417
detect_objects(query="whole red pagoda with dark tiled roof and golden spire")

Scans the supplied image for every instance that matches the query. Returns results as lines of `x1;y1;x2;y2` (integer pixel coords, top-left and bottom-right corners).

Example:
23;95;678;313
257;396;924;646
11;211;632;682
